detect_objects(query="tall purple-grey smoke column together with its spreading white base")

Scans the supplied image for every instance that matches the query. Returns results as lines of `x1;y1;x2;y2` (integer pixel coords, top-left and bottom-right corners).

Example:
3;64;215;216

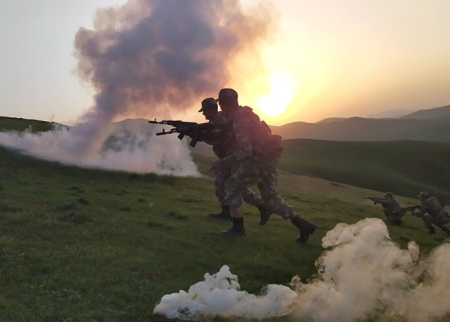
0;0;276;175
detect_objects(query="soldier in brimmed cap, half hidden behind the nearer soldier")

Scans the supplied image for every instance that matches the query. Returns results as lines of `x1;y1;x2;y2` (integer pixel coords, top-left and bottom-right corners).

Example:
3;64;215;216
198;97;271;225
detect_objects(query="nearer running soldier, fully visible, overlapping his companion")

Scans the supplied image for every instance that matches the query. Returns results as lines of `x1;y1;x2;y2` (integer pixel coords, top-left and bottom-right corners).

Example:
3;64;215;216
208;88;316;243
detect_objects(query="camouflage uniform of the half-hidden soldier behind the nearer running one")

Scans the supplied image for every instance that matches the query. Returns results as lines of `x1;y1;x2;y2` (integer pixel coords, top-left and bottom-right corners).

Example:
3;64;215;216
204;112;264;207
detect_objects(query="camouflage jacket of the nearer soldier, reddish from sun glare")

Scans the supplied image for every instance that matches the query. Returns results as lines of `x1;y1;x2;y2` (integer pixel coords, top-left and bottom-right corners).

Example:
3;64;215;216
224;106;283;165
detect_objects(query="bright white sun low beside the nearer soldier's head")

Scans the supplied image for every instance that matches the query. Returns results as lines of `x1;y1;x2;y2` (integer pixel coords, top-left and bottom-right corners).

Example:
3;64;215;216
255;72;295;116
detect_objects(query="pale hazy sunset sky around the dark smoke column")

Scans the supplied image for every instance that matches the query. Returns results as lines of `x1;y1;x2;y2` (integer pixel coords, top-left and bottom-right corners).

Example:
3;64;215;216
0;0;450;125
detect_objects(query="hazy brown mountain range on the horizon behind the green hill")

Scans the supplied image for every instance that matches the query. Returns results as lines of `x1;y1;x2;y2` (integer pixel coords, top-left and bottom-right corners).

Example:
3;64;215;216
271;105;450;141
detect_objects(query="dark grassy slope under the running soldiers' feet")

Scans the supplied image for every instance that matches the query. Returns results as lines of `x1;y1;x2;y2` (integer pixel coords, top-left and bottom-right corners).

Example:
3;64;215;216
0;117;444;321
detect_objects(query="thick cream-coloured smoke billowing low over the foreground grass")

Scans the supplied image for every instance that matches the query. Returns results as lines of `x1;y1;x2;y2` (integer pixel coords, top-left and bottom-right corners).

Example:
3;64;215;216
153;218;450;322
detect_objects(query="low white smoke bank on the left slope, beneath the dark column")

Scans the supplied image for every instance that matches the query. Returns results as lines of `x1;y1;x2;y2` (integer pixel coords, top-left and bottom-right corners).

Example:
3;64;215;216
0;120;199;176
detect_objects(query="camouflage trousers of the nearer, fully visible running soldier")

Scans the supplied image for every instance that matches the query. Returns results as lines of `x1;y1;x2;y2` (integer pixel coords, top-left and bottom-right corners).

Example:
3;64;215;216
222;157;296;219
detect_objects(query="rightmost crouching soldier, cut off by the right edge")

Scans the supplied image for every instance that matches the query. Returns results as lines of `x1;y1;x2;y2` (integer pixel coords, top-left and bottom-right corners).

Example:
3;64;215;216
411;191;450;236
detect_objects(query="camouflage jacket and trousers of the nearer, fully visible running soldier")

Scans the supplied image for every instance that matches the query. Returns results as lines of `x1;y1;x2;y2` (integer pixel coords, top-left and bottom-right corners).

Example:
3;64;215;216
223;106;295;219
